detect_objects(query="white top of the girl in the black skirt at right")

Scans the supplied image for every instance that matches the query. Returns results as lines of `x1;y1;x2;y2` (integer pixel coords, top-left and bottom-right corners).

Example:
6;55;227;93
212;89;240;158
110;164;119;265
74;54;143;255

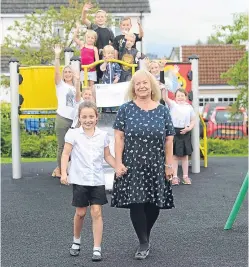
169;100;195;128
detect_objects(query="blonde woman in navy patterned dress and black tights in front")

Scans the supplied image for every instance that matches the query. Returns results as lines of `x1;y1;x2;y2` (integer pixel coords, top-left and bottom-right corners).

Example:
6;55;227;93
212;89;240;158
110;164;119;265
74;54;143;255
111;70;175;259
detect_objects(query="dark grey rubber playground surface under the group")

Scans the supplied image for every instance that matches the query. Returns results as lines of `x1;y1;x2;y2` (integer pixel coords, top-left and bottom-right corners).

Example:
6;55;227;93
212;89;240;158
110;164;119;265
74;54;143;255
1;155;248;267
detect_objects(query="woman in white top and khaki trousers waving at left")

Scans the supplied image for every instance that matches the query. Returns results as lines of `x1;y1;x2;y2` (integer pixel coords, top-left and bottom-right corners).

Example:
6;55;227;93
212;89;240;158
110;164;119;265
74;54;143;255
52;45;80;178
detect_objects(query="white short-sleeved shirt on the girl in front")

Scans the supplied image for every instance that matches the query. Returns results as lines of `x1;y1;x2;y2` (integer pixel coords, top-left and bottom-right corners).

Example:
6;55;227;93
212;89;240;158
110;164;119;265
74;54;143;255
65;127;110;186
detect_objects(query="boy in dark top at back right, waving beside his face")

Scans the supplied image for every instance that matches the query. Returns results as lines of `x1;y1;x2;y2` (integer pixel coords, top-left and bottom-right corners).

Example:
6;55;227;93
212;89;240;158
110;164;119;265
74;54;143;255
113;17;144;59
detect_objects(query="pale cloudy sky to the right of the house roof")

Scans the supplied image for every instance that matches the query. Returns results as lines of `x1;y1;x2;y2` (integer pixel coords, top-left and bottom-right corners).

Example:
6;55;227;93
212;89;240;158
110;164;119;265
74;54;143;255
143;0;249;56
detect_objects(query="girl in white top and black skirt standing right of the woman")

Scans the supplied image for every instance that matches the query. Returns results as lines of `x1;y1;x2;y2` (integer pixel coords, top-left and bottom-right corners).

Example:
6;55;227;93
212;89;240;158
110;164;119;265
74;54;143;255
165;89;195;185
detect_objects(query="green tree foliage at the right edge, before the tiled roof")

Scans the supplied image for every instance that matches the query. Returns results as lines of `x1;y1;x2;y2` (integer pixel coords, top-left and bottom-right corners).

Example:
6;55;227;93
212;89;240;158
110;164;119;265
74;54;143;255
210;13;248;109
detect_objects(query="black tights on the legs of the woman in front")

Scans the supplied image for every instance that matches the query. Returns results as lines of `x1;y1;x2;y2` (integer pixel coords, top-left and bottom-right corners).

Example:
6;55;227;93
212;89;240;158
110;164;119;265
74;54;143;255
130;203;159;244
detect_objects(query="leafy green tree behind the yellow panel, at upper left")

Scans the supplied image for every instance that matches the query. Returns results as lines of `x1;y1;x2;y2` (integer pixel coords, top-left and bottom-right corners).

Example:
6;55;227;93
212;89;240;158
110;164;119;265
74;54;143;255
2;0;97;65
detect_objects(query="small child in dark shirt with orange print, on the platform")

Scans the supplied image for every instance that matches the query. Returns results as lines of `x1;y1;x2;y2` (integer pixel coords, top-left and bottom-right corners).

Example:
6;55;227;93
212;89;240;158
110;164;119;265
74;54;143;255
118;33;142;82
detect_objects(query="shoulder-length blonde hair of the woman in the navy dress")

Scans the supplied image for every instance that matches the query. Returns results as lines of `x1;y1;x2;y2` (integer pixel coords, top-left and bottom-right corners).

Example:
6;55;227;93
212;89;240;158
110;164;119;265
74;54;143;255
125;70;161;101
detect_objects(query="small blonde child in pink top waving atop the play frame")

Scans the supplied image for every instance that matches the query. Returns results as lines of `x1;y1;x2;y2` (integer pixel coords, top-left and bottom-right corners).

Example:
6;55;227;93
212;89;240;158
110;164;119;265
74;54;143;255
73;24;99;87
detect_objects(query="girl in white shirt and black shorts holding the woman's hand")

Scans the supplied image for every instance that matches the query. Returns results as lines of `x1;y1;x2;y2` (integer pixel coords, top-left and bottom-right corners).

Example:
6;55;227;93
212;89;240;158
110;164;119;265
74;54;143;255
61;101;118;261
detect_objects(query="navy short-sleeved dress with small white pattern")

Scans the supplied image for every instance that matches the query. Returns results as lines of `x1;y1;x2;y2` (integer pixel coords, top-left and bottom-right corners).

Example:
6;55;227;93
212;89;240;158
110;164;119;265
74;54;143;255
111;101;175;209
